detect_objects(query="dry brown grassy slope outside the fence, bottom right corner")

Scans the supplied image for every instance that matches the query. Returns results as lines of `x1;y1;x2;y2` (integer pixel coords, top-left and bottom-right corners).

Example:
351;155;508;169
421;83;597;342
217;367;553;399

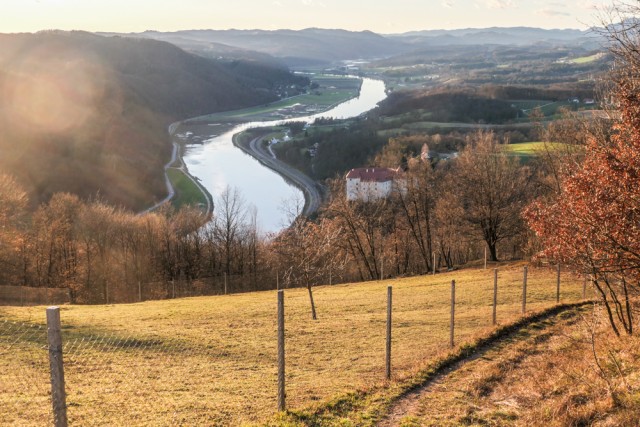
401;306;640;427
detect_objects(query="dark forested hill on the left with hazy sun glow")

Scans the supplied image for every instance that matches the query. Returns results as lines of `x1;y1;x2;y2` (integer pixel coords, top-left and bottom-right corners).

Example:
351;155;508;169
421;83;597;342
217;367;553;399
0;31;306;209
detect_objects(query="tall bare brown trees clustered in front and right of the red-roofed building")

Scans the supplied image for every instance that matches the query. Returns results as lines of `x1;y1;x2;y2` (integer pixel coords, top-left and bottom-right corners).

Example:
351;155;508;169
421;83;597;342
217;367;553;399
312;132;535;280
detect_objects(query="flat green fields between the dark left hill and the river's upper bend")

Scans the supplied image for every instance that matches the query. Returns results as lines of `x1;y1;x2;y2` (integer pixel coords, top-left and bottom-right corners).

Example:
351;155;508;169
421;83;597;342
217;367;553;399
190;75;361;122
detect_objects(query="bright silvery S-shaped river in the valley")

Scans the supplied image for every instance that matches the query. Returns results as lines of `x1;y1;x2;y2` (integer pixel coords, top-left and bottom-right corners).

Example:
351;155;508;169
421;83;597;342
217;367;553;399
183;78;386;233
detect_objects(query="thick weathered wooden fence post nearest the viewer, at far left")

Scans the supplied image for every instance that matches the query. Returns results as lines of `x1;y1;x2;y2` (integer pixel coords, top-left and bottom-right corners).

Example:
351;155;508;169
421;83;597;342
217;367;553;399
47;307;67;427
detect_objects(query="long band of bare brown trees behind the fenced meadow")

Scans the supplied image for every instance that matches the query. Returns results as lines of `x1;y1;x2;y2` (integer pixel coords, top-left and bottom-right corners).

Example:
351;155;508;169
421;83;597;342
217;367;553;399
0;129;533;303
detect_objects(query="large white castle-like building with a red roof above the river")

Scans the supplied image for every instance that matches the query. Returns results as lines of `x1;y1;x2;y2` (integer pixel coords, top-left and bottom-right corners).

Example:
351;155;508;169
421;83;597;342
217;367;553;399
346;168;406;202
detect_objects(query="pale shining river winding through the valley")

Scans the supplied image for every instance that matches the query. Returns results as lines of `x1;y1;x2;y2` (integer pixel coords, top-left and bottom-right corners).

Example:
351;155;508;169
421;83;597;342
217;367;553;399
176;78;387;233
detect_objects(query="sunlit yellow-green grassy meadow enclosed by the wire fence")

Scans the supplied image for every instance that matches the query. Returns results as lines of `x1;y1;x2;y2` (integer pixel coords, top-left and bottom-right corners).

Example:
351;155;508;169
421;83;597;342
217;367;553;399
0;264;583;425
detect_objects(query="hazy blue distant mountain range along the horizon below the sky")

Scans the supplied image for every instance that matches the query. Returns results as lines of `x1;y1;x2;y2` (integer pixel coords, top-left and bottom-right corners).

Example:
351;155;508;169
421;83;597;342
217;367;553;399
102;27;600;66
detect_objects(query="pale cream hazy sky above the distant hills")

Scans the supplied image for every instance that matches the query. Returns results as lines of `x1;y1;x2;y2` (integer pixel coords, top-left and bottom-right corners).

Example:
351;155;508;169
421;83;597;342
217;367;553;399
5;0;611;33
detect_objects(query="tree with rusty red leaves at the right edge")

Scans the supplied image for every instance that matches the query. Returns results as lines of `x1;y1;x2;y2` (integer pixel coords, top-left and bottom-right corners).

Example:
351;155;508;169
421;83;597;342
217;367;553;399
524;13;640;335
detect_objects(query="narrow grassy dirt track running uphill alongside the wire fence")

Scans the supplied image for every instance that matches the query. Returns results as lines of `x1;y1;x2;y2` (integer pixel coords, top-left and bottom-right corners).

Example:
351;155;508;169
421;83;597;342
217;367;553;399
377;307;592;427
